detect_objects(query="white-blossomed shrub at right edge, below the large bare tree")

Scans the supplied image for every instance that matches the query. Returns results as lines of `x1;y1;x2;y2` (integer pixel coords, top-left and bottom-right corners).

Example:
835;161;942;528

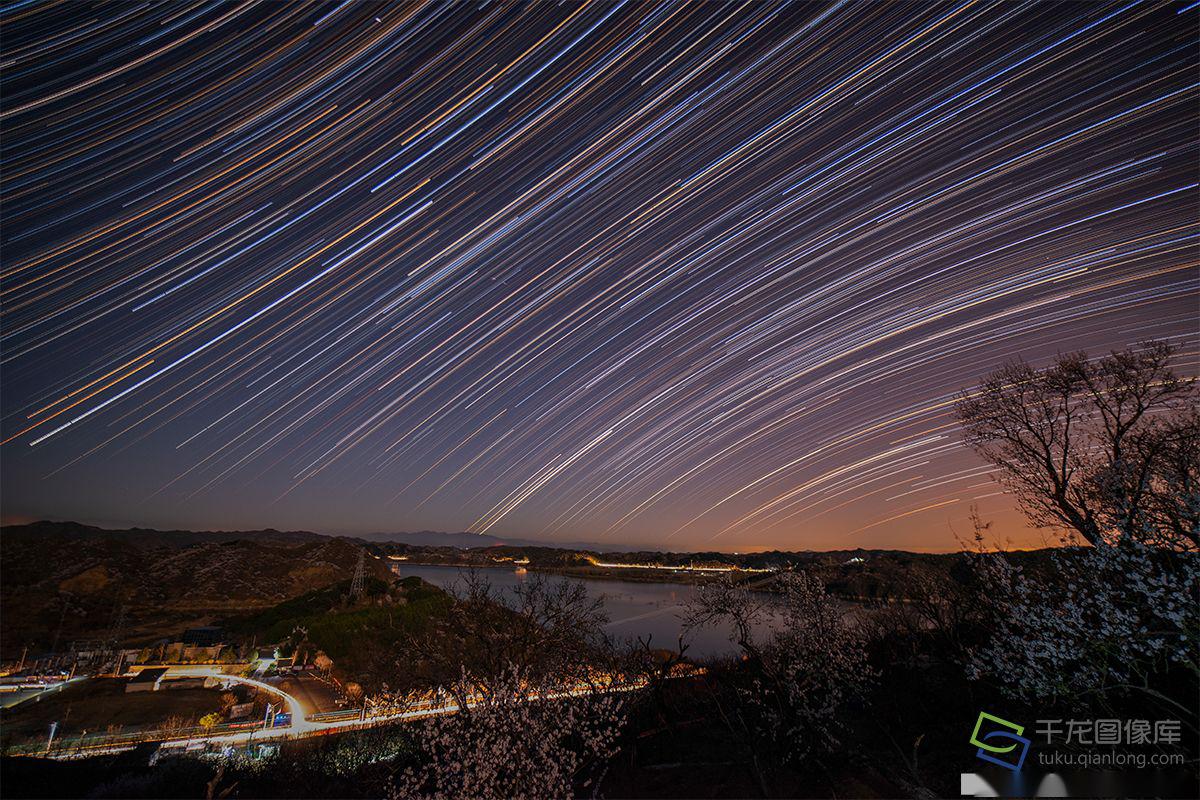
967;539;1200;700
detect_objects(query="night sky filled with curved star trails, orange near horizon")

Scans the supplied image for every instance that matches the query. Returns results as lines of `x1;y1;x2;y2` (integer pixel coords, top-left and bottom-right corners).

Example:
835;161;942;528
0;0;1200;551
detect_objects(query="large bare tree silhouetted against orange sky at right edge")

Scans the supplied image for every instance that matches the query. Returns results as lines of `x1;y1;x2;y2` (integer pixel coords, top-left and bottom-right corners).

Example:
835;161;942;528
955;342;1200;549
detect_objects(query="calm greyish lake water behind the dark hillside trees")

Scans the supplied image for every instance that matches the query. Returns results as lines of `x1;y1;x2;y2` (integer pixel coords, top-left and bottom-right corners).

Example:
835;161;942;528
394;561;737;658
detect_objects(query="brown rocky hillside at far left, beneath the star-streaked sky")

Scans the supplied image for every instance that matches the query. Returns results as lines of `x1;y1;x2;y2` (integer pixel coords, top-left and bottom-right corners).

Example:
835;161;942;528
0;523;391;657
